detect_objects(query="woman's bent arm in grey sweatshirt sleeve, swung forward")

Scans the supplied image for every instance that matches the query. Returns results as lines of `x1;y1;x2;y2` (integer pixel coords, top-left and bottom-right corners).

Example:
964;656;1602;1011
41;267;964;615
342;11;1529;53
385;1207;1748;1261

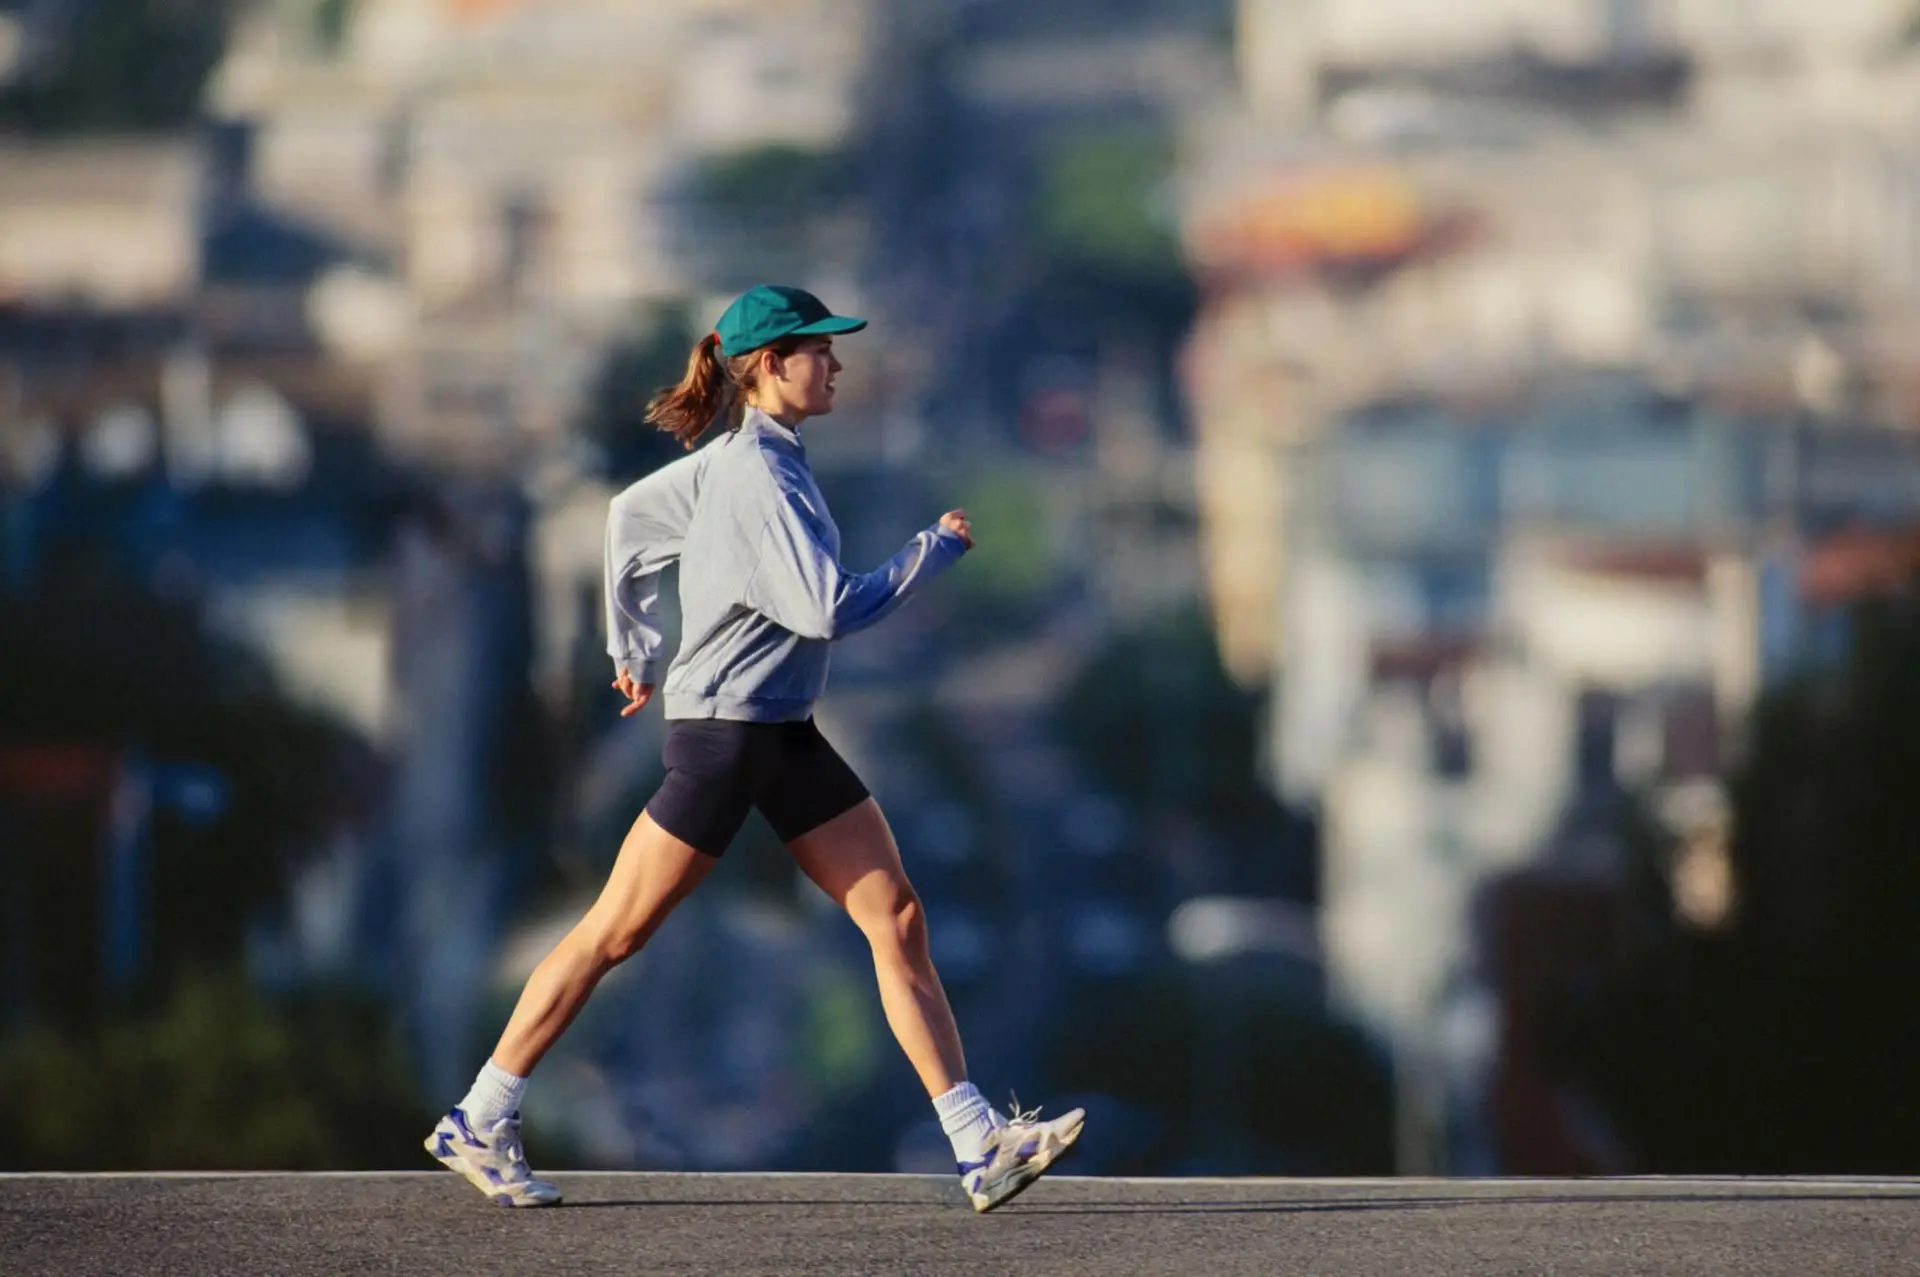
743;483;966;639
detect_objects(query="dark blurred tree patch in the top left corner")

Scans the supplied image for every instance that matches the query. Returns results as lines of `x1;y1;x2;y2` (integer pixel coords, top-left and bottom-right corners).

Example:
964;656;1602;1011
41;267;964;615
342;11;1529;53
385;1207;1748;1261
0;0;234;133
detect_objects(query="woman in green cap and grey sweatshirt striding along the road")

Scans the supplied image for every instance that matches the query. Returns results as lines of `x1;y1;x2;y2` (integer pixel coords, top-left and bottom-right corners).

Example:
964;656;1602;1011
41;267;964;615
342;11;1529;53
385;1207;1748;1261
426;284;1083;1210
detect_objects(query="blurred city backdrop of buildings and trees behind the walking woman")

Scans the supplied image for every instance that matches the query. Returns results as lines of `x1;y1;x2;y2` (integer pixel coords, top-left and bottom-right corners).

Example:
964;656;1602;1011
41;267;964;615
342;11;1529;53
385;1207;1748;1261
0;0;1920;1175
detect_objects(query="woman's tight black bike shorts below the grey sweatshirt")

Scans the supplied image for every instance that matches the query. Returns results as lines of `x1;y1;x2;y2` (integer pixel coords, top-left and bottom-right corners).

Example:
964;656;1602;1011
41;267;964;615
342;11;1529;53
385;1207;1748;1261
647;718;868;856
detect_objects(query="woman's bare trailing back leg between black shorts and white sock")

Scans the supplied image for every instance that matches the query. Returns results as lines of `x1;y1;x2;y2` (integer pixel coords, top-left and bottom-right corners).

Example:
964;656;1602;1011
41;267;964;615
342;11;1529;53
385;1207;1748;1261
493;812;718;1077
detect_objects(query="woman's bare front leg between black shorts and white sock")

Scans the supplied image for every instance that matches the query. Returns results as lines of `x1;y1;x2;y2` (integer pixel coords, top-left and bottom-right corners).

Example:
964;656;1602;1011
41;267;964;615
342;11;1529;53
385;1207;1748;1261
787;799;966;1096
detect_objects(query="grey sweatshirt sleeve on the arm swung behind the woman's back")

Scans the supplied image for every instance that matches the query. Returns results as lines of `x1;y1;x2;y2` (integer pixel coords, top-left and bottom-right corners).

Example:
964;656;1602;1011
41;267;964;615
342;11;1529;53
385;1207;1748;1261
607;455;699;684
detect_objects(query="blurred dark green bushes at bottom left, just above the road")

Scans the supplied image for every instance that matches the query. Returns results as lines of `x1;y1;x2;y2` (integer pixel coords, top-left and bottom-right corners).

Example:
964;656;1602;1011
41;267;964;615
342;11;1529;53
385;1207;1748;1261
0;976;426;1169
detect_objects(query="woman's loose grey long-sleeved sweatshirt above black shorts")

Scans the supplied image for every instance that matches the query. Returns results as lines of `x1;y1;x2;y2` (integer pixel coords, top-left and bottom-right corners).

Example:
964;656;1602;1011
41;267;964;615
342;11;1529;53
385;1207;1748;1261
607;409;966;722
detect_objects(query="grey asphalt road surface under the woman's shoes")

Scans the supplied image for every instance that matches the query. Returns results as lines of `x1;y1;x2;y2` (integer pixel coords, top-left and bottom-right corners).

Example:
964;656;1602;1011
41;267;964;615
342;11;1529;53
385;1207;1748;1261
0;1171;1920;1277
